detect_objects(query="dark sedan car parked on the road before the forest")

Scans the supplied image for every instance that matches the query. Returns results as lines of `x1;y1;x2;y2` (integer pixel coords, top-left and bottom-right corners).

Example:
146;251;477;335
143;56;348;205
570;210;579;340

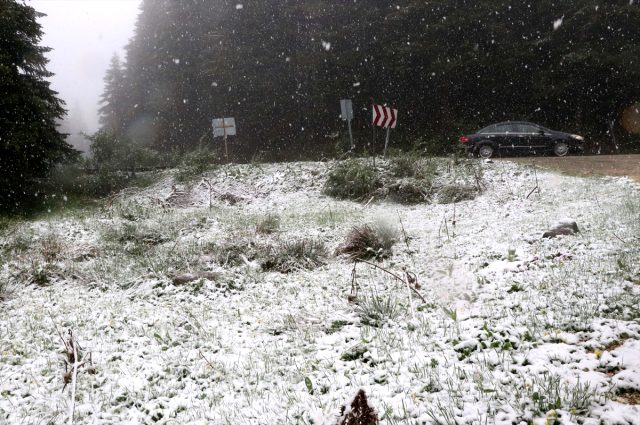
460;121;584;158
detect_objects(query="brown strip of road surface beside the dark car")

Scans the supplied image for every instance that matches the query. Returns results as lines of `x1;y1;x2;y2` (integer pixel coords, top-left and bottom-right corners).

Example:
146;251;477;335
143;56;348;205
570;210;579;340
505;155;640;181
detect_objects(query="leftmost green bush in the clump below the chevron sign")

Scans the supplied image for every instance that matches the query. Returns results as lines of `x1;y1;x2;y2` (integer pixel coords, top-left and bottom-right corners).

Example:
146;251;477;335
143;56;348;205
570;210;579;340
324;159;382;200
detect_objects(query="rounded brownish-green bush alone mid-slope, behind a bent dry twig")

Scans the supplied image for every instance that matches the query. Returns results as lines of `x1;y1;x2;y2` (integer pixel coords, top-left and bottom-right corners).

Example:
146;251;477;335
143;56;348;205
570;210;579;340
336;223;397;260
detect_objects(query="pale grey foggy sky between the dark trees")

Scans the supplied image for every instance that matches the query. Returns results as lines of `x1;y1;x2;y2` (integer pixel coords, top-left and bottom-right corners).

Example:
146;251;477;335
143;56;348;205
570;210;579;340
27;0;140;132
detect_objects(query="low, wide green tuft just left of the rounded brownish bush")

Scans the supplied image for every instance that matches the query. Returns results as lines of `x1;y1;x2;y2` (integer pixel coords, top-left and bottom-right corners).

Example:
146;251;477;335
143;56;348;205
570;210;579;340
262;239;328;273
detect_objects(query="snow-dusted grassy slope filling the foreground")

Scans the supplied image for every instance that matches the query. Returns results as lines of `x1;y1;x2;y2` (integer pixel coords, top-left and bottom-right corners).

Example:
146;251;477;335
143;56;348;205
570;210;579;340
0;160;640;424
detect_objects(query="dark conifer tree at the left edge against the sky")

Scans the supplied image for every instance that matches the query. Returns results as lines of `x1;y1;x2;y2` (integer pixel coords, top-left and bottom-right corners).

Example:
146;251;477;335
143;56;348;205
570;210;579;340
0;0;76;212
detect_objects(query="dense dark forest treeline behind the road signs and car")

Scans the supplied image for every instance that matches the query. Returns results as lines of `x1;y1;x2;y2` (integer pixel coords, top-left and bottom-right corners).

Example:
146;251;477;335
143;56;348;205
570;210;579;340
102;0;640;159
